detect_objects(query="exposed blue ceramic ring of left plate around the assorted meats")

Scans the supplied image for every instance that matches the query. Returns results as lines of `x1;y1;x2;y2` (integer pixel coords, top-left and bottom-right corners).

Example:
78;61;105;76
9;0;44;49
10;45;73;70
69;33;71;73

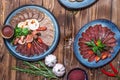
4;5;60;61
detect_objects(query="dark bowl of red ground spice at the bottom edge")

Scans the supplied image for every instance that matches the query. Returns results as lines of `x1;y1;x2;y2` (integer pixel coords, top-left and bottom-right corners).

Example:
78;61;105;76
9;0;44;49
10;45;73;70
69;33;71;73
67;68;87;80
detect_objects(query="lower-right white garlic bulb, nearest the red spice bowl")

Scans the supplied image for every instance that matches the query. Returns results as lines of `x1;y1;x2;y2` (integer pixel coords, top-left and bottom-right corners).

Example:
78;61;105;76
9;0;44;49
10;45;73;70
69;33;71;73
52;63;65;77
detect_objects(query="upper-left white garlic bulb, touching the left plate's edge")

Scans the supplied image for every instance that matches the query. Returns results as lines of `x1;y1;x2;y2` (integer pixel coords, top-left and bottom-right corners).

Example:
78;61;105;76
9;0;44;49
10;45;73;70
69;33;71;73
45;54;57;67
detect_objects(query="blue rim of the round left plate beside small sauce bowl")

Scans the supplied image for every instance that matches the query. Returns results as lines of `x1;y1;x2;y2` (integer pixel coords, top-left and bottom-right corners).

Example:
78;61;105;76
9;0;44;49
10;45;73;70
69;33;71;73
3;4;60;61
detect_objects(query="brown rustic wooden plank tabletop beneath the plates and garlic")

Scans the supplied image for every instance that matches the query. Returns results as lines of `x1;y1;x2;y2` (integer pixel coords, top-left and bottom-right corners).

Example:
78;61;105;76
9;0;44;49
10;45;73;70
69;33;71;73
0;0;120;80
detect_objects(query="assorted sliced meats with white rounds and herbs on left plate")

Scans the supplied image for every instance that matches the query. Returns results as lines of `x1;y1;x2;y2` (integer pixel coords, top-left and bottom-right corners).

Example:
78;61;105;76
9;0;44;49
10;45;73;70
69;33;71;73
10;8;55;56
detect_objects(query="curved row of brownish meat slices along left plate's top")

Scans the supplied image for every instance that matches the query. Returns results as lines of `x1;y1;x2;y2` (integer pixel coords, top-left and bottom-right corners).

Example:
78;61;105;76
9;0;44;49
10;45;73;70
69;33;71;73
10;8;46;27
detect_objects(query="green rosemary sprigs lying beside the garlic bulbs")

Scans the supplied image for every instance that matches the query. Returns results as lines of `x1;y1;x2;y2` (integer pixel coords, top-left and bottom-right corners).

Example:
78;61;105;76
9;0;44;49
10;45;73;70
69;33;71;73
12;61;58;80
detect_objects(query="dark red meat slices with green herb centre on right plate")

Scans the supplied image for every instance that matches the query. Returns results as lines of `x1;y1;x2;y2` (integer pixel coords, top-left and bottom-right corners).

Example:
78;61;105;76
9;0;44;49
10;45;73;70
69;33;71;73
78;24;116;62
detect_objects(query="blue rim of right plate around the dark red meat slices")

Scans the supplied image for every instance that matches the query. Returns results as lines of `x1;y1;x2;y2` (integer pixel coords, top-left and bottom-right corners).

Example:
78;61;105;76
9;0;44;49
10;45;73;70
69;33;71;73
73;19;120;68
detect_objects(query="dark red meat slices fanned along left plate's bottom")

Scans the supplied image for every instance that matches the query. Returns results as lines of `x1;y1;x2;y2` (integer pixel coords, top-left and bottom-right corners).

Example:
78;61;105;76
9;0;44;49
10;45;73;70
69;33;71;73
16;40;48;56
